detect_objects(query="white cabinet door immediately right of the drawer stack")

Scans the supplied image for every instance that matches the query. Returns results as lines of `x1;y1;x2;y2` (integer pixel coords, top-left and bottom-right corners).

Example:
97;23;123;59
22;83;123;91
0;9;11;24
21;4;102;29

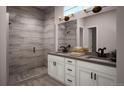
77;67;94;86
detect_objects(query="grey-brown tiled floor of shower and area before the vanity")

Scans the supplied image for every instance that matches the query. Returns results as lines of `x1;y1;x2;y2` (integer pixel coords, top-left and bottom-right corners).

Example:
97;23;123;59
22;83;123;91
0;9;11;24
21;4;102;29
8;67;63;86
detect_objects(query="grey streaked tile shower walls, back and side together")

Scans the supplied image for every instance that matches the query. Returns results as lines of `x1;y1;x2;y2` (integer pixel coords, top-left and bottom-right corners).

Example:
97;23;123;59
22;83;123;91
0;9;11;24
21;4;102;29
7;7;54;73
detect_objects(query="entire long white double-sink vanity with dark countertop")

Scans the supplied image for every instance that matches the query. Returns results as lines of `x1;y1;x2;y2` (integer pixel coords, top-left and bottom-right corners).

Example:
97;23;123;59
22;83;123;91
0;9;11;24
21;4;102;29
48;52;116;86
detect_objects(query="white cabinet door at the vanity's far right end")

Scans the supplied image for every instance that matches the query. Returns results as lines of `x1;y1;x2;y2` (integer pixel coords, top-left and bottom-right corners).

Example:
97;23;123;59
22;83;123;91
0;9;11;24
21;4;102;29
96;73;116;86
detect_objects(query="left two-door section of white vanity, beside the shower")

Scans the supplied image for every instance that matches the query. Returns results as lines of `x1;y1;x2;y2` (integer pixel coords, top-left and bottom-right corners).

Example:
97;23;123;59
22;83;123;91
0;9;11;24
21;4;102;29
48;55;65;83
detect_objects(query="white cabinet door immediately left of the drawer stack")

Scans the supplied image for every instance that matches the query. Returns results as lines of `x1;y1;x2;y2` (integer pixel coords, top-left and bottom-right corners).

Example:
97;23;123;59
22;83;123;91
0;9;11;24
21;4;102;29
56;62;64;83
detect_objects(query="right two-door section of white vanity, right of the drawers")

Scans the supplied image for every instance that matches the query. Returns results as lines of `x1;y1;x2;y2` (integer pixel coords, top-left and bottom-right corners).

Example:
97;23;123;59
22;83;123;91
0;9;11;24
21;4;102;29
76;61;116;86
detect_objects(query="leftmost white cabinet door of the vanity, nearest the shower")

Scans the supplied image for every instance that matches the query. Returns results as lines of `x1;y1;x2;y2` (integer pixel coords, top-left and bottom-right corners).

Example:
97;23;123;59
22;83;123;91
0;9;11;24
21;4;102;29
48;59;57;78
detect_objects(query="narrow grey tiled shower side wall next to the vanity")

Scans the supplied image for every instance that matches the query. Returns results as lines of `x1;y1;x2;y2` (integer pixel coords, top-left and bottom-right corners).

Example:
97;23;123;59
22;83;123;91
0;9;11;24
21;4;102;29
43;7;55;66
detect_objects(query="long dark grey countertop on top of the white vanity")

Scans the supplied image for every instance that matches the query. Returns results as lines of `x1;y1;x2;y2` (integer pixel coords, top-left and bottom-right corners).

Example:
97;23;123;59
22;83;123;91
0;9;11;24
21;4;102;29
48;52;116;67
